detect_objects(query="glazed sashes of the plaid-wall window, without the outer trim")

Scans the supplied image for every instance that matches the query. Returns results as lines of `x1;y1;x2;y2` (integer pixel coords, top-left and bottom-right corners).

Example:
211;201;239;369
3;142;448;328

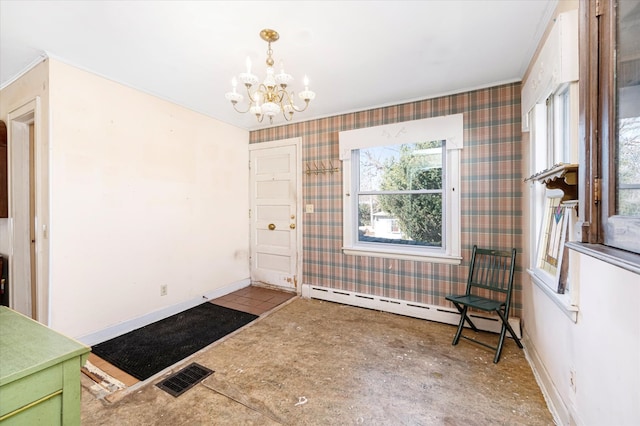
352;141;445;248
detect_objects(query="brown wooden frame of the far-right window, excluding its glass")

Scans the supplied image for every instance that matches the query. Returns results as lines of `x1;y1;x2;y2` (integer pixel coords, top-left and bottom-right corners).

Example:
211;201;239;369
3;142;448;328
578;0;640;253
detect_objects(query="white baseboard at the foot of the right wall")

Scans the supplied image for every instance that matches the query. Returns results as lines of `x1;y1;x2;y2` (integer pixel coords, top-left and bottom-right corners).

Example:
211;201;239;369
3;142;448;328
522;332;576;426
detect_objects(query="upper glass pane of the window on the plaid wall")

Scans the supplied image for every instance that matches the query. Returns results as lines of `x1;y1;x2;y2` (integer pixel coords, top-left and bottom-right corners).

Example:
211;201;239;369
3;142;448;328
359;141;444;192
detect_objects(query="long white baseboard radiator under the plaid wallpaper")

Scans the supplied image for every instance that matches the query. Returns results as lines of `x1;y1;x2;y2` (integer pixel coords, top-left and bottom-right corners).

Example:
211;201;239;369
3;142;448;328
302;284;521;338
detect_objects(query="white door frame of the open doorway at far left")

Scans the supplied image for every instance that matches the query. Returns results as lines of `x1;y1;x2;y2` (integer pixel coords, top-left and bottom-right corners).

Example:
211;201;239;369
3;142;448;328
7;96;49;325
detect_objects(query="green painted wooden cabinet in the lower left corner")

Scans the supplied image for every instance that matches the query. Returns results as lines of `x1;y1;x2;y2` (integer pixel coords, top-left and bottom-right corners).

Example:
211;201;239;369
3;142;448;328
0;306;90;426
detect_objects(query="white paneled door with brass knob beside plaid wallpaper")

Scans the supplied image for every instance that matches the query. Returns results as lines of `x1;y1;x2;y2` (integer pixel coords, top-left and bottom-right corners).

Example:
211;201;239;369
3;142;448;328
250;139;299;290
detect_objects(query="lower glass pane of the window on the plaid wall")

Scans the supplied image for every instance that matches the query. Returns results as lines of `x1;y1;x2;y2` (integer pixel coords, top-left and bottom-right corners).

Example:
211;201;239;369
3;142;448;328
358;193;442;247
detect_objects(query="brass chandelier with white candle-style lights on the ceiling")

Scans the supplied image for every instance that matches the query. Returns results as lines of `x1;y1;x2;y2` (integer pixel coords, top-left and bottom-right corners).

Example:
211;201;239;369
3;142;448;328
225;29;316;123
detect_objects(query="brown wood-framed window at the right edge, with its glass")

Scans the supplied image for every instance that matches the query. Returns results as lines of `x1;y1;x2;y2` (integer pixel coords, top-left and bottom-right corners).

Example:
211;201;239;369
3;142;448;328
580;0;640;254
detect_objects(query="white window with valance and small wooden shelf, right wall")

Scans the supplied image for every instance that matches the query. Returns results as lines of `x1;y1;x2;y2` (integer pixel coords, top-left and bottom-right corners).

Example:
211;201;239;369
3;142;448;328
522;10;579;300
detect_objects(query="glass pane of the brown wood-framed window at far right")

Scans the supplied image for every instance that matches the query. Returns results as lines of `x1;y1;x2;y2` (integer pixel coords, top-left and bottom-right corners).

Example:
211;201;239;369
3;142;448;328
616;1;640;216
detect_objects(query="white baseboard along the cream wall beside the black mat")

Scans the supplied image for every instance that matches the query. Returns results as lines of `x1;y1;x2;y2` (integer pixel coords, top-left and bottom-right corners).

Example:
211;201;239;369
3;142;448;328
76;278;251;346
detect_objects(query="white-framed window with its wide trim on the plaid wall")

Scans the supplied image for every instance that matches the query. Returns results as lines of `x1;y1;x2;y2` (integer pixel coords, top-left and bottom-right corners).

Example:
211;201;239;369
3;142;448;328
340;114;463;264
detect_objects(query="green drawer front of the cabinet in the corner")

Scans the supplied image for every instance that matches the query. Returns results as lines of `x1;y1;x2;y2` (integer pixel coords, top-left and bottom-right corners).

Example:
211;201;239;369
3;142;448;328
0;364;63;418
